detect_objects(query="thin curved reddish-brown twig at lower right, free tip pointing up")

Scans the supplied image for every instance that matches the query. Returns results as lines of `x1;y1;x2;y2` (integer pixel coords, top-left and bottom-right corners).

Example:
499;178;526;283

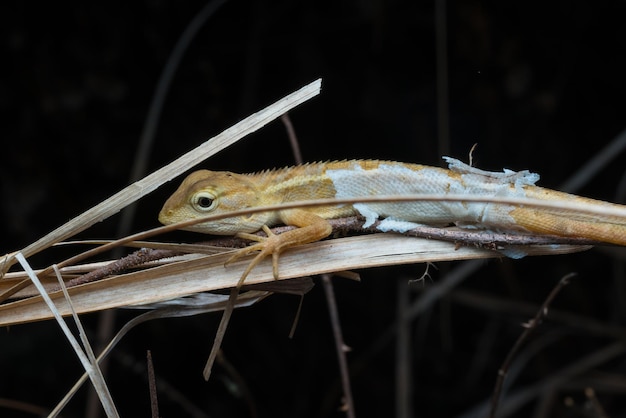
489;273;576;418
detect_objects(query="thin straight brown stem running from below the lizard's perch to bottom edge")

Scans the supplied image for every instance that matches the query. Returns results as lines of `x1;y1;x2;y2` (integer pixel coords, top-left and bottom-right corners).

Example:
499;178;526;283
322;274;356;418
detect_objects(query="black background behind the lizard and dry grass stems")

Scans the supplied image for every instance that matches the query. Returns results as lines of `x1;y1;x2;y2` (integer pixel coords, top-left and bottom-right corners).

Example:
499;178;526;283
0;0;626;417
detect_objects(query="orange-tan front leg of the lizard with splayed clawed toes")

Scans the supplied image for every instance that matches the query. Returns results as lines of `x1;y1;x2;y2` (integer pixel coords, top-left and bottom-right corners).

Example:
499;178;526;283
226;209;333;288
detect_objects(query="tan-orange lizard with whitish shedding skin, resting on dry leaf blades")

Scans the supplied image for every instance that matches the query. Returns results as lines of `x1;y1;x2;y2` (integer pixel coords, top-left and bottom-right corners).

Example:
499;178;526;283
158;157;626;287
